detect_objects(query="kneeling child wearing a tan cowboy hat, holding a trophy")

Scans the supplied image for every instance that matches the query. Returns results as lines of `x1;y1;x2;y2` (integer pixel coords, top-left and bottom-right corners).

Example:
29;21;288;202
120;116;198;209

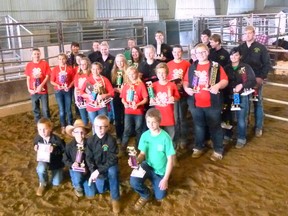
63;119;89;197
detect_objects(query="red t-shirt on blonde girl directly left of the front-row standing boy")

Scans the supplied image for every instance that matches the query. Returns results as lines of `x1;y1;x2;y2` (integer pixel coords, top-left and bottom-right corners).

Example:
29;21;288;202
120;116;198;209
120;82;148;115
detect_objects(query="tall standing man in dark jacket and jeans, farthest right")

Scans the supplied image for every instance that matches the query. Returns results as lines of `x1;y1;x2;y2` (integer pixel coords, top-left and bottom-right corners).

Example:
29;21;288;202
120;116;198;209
239;26;271;137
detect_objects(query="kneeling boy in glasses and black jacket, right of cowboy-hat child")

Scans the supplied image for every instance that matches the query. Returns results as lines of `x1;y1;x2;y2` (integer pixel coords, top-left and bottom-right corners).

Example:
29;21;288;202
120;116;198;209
86;115;120;214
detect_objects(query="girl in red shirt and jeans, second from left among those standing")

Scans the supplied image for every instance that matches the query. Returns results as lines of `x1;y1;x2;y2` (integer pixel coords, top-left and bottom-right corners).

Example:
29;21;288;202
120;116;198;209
50;53;74;134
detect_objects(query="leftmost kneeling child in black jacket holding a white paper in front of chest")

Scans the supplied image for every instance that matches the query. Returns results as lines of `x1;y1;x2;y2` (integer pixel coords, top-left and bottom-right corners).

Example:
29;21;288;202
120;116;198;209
34;118;65;196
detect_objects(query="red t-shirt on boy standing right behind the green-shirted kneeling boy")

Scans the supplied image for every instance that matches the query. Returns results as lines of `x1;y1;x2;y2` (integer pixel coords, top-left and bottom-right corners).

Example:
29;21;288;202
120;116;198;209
153;81;180;126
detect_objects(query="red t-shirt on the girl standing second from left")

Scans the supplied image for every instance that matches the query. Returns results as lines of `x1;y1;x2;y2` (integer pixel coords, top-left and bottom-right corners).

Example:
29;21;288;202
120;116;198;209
50;66;74;90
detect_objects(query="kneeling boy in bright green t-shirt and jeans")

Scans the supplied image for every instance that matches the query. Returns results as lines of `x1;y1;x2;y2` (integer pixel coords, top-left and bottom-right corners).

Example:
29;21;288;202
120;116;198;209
128;108;175;210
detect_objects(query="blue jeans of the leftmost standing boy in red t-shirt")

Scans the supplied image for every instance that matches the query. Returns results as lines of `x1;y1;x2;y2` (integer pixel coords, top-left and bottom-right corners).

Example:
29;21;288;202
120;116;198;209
31;94;50;123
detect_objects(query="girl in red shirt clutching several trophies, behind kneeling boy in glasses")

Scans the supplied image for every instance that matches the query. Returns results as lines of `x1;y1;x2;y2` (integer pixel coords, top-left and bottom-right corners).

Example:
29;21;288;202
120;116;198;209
81;62;114;132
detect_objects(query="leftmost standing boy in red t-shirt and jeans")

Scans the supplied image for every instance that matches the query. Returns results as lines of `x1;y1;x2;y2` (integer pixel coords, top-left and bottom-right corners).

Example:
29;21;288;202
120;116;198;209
25;48;51;123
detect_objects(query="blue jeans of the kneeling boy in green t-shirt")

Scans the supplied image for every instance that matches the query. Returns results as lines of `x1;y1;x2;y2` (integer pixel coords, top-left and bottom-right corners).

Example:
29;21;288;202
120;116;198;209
130;161;167;200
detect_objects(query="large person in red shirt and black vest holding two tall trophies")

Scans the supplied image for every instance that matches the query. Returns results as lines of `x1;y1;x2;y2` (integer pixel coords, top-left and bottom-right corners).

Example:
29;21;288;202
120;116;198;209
183;43;228;161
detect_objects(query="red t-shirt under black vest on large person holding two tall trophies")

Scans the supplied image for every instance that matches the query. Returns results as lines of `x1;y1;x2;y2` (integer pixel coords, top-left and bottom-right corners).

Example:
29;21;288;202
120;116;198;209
184;63;228;108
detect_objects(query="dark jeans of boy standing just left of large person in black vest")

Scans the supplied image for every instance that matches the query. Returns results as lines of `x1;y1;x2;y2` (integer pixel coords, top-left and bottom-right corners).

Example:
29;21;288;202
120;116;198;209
174;97;188;142
